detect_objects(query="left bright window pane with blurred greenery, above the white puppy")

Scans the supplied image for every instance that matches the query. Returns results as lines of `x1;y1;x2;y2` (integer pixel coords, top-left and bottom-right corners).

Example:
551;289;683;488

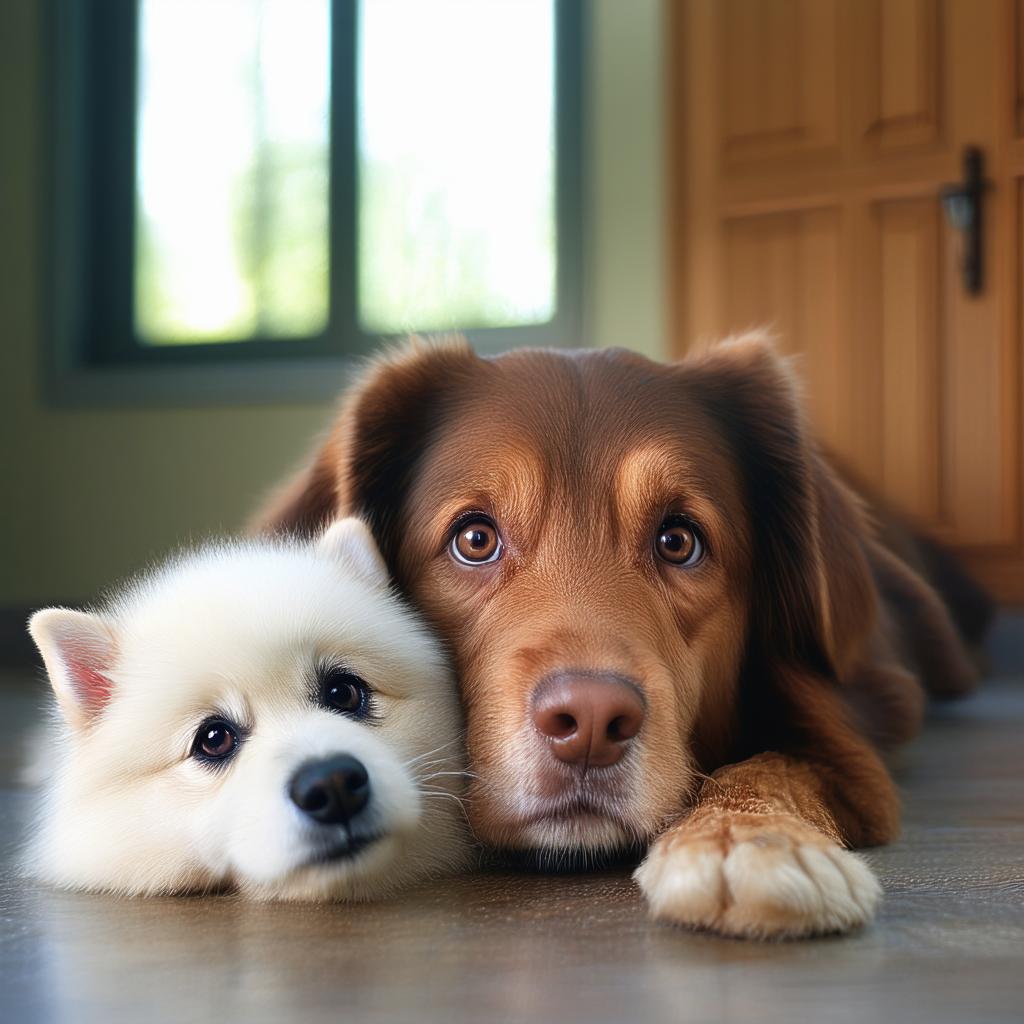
135;0;330;344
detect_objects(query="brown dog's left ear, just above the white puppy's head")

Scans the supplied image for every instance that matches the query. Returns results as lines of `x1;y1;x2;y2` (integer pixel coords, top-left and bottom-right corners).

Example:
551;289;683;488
252;337;481;556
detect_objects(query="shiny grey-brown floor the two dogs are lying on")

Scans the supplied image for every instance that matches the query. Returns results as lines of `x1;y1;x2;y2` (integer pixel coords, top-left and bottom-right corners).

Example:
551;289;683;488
0;633;1024;1024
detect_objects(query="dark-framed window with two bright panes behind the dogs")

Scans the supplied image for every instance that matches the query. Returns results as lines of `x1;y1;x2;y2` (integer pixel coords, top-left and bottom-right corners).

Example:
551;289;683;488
51;0;582;387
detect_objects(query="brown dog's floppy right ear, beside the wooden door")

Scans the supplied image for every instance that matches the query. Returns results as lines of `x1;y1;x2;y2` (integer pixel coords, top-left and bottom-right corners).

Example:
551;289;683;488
682;334;877;676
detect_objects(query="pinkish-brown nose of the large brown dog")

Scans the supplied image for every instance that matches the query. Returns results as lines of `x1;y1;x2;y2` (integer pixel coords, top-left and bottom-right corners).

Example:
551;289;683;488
531;672;644;769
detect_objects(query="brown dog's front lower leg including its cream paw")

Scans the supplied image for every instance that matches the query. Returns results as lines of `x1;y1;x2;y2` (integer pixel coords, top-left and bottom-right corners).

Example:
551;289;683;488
635;754;882;938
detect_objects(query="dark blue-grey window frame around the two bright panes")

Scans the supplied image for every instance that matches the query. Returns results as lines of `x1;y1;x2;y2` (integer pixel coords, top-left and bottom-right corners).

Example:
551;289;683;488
43;0;586;403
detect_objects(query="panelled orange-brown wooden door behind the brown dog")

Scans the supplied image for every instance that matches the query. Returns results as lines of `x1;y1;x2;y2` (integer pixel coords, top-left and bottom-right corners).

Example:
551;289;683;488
668;0;1024;603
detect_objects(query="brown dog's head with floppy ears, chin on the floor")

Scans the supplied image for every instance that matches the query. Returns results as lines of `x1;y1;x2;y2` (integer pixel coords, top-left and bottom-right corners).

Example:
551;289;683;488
260;338;871;856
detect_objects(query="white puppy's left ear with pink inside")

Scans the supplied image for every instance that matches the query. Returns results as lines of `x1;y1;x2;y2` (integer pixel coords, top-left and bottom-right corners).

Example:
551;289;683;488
29;608;117;729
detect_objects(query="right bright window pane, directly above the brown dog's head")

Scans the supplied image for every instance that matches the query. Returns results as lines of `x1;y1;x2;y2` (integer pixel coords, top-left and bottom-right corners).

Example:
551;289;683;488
358;0;556;333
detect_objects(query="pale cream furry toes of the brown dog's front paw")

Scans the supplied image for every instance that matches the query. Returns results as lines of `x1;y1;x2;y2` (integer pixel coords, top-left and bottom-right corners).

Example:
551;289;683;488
634;813;882;939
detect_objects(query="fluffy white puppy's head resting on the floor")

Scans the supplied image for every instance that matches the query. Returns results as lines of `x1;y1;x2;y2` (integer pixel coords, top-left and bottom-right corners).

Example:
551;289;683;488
28;519;468;899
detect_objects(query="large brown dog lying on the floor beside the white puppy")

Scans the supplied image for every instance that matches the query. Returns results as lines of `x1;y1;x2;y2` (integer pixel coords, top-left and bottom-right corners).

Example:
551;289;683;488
261;336;987;936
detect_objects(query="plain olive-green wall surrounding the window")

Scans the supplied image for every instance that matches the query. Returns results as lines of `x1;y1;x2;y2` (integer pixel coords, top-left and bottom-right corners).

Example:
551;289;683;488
0;0;665;608
